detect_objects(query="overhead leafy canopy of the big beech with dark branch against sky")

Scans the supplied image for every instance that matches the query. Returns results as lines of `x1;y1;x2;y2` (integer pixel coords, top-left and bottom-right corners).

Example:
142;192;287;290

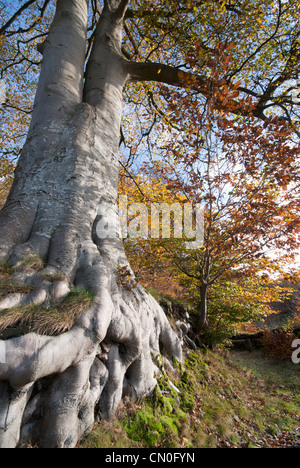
0;0;300;173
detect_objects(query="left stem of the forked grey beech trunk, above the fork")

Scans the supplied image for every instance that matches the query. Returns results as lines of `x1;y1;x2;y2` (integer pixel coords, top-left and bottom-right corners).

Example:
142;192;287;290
31;0;88;128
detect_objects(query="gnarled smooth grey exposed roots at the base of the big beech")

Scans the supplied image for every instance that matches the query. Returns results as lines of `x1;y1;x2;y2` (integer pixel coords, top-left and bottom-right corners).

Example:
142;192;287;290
0;239;181;448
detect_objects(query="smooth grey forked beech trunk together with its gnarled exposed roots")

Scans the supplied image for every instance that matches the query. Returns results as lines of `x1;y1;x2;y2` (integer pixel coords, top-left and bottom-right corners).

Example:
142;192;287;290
0;0;182;448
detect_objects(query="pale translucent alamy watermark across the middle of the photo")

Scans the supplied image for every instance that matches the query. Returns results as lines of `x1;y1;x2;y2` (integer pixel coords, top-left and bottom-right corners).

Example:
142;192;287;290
96;195;204;249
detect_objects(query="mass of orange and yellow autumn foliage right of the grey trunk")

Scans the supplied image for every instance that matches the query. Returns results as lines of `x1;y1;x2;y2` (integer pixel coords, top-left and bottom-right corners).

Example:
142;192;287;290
118;37;300;336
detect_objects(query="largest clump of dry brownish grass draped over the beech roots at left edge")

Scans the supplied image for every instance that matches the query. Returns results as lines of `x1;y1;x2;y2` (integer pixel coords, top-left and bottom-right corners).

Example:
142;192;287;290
0;290;93;336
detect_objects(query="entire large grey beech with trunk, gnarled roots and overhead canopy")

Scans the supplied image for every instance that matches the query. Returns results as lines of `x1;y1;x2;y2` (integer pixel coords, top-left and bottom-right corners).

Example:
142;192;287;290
0;0;299;447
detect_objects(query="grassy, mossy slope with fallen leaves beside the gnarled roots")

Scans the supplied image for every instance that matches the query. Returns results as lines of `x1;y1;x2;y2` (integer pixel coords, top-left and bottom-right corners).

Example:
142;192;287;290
79;350;300;448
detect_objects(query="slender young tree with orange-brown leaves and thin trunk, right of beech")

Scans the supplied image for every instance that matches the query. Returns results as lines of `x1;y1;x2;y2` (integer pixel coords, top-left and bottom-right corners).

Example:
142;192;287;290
146;53;300;331
